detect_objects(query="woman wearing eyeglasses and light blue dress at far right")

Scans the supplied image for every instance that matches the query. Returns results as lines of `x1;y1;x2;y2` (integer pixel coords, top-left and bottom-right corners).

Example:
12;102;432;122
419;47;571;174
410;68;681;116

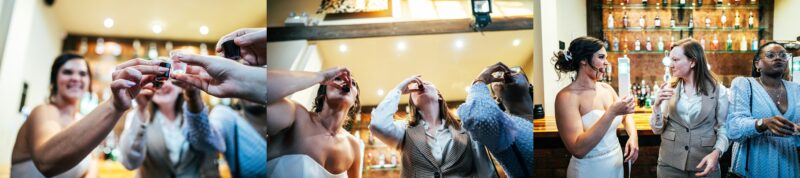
727;42;800;177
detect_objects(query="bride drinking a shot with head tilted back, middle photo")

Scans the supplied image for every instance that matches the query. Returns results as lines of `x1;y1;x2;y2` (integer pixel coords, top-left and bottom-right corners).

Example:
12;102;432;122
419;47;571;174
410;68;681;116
267;68;363;178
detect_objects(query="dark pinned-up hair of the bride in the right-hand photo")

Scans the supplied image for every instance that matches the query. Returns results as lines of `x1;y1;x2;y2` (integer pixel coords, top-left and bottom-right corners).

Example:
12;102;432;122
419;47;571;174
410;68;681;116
552;36;606;79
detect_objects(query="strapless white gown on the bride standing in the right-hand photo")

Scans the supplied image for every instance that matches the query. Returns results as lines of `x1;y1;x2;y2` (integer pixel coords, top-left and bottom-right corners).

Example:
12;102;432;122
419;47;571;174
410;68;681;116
567;110;625;178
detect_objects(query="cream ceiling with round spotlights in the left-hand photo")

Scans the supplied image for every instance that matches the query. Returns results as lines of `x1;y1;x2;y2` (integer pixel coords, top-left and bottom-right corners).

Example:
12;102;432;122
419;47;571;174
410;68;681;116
51;0;267;42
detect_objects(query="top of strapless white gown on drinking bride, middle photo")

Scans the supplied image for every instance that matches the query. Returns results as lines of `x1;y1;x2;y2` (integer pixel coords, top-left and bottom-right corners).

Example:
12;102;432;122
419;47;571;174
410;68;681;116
267;154;347;178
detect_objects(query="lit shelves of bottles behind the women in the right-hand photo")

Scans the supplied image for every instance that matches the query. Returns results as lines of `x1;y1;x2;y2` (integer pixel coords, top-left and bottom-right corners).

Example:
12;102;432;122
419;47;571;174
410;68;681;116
589;0;771;110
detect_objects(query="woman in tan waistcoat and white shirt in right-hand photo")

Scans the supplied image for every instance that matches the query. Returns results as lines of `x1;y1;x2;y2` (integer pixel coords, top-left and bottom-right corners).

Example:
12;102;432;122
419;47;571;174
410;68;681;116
650;39;728;177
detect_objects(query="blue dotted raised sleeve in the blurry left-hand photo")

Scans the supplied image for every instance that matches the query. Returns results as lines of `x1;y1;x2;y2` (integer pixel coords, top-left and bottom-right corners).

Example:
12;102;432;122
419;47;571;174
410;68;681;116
183;103;225;152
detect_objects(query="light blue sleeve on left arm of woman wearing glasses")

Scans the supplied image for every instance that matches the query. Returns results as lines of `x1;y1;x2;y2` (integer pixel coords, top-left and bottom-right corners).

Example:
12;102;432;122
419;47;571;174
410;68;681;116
726;77;760;142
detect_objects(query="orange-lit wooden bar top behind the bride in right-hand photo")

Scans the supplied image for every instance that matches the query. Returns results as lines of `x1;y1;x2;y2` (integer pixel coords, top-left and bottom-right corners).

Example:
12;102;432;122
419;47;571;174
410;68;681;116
533;108;654;138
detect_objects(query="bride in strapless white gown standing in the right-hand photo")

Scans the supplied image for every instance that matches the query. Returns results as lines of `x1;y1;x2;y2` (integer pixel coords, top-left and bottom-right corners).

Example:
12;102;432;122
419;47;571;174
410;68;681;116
553;37;639;178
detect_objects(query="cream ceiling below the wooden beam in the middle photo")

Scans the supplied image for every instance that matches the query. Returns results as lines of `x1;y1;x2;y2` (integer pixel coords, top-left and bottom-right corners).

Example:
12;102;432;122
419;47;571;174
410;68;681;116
310;30;533;106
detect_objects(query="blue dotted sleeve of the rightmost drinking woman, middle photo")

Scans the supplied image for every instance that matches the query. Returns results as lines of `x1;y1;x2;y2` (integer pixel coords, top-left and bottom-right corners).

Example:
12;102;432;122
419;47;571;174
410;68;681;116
458;83;518;153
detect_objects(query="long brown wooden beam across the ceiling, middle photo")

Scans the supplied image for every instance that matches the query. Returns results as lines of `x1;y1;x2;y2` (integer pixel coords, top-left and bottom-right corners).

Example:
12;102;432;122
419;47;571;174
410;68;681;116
267;17;533;42
